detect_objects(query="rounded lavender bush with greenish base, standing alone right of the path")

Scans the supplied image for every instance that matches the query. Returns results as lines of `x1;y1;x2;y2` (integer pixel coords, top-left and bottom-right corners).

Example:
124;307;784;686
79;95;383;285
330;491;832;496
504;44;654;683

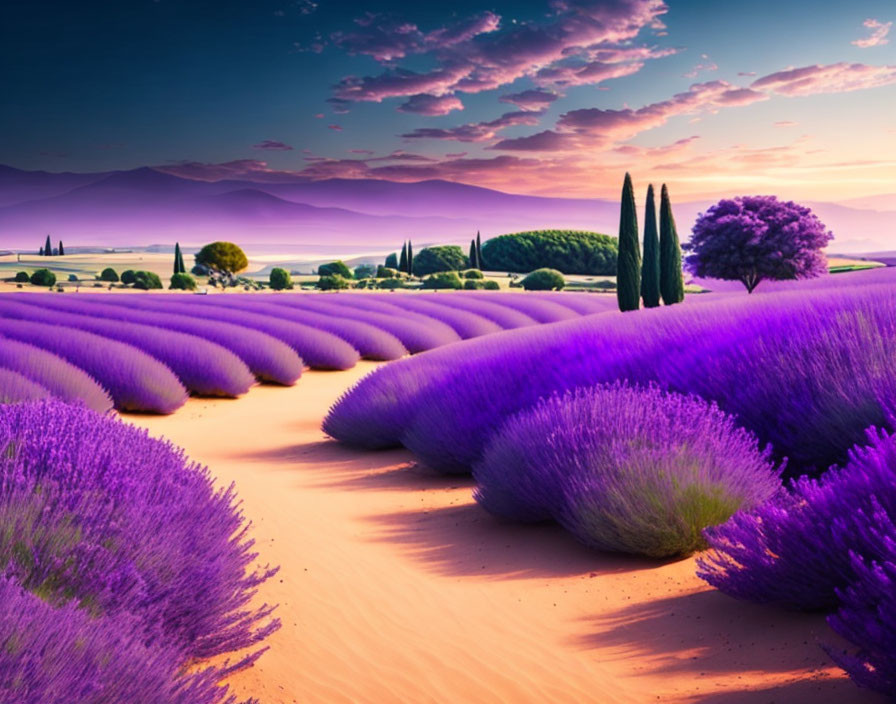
473;383;780;557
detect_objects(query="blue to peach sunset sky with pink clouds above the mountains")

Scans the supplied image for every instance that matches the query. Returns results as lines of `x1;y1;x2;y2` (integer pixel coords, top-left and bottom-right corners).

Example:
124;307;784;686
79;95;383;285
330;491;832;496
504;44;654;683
0;0;896;200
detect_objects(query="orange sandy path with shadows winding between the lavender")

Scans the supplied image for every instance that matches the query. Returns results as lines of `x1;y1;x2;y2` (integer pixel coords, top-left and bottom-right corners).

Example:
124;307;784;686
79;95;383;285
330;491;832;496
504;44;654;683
129;363;879;704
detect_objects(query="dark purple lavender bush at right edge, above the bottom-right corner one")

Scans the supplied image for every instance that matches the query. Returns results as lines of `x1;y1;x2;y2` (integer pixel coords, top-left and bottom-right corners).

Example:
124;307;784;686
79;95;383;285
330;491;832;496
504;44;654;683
697;429;896;610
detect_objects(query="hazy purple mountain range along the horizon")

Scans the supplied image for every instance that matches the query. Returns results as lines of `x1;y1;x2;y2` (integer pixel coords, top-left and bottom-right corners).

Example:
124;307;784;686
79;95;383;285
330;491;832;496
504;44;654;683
0;166;896;252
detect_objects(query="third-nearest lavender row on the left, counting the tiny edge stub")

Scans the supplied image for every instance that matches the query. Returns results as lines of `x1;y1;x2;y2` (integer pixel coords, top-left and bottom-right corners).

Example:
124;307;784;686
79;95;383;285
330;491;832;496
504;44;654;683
0;314;187;413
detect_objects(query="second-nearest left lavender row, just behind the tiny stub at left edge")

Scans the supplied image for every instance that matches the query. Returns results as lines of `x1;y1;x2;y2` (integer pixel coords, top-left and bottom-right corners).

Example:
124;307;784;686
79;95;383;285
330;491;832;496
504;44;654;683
0;335;112;413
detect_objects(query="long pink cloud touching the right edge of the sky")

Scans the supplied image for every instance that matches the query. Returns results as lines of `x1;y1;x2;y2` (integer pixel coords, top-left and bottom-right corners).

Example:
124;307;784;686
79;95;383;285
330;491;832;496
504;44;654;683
751;62;896;95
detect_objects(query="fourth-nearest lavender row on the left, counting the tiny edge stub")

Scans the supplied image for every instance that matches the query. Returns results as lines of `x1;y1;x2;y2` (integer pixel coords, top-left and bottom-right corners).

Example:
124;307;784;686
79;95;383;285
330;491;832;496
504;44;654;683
0;296;255;397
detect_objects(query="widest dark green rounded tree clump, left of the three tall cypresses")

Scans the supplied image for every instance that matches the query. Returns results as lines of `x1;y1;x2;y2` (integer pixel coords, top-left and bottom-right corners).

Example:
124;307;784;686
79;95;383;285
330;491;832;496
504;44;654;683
482;230;618;276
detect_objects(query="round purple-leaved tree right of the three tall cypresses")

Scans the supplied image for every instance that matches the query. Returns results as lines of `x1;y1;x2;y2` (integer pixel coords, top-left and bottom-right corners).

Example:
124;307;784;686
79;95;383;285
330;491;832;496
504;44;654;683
684;196;834;293
